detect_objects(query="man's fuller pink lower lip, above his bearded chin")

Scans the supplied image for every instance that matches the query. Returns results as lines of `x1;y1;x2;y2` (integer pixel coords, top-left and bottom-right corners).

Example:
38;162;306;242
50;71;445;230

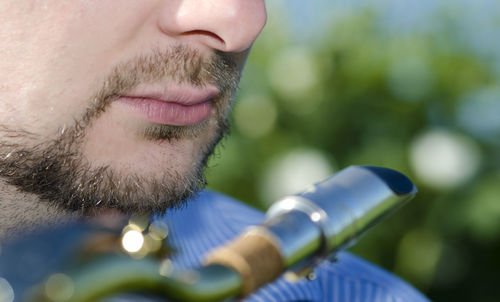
116;97;211;126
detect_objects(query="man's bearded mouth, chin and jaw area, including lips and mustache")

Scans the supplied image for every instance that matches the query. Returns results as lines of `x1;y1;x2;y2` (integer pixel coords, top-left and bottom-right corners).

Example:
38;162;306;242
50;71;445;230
0;48;239;215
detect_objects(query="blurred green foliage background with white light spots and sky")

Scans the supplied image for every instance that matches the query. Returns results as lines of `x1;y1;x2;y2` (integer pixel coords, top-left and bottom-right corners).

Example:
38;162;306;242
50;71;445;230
208;0;500;301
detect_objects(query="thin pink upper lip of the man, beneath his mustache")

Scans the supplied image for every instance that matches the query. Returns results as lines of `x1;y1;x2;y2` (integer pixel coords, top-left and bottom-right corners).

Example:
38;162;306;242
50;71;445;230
122;86;219;106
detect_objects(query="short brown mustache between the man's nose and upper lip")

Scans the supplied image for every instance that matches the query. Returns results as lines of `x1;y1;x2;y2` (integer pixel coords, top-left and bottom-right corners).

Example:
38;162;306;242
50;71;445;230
81;45;240;126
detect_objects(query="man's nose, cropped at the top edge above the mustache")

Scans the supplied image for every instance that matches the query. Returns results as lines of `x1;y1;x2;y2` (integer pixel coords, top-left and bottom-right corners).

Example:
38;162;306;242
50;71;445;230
158;0;267;52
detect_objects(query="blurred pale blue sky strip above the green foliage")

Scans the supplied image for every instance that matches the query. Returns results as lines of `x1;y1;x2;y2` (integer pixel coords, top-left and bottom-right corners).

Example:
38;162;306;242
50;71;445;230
278;0;500;42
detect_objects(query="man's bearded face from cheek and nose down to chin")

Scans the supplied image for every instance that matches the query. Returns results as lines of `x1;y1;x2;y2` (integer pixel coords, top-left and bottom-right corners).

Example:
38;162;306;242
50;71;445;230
0;0;266;214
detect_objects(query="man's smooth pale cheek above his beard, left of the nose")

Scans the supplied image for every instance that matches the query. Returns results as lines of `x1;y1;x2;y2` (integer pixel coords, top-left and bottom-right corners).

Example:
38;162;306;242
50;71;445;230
0;0;154;134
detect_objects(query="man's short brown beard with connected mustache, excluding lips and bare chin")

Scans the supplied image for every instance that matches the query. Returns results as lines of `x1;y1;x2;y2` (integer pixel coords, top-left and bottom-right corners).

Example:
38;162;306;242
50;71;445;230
0;46;239;216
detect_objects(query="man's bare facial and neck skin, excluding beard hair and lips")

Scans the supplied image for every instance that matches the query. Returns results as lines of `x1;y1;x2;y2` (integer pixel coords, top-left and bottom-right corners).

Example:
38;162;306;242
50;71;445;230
0;0;266;237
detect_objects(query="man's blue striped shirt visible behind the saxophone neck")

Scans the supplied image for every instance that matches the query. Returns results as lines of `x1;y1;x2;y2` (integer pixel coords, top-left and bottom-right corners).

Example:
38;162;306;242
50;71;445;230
156;191;428;302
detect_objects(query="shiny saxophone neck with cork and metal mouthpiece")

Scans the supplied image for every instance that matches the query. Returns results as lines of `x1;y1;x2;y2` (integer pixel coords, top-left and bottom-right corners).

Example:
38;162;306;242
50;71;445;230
0;166;417;302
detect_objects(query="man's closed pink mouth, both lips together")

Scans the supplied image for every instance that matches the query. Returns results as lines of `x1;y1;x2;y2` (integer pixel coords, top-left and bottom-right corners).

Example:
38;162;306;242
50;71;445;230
114;87;219;126
